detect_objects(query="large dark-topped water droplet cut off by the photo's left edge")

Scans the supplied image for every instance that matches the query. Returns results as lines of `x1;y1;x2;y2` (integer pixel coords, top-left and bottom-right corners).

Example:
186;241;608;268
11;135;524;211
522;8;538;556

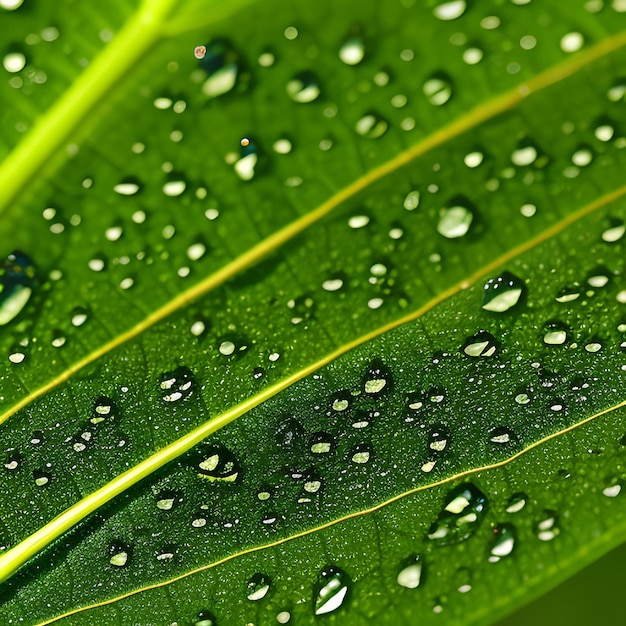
0;250;35;326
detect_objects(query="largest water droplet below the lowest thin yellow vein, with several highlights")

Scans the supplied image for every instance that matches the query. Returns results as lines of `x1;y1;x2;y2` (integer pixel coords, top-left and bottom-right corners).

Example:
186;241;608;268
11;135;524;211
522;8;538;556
428;483;487;546
